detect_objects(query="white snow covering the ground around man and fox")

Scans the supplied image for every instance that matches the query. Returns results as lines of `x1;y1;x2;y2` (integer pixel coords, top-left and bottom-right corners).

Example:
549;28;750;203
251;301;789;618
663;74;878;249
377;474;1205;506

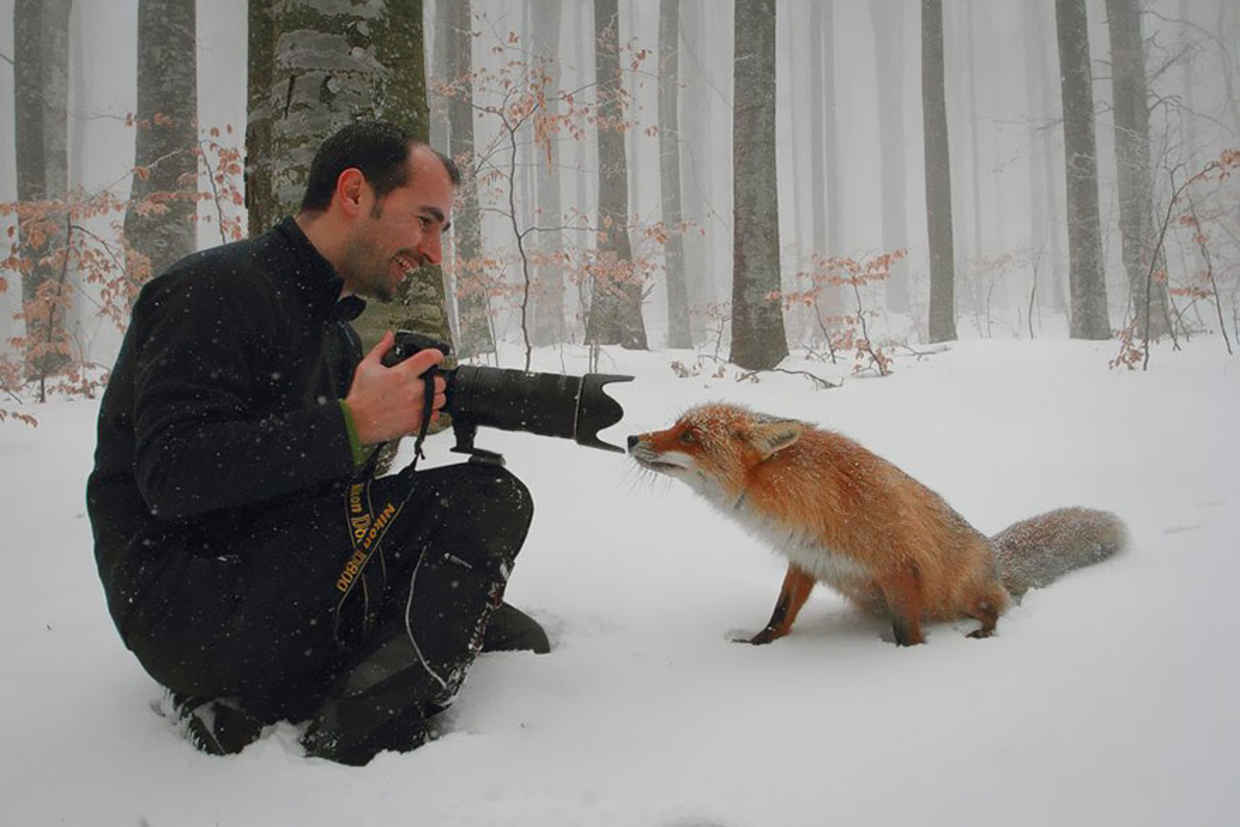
0;337;1240;827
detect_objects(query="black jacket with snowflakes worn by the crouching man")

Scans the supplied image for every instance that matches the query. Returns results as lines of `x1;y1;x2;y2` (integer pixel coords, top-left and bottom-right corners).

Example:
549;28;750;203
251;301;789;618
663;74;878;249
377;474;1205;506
87;218;362;641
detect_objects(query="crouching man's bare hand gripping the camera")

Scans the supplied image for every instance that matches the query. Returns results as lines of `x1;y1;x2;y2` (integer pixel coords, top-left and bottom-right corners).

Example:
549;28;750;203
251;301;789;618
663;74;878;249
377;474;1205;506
345;330;446;445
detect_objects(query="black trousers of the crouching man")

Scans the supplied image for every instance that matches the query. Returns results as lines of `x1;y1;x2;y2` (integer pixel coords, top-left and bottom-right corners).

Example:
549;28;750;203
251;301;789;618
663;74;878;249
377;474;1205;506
126;464;533;720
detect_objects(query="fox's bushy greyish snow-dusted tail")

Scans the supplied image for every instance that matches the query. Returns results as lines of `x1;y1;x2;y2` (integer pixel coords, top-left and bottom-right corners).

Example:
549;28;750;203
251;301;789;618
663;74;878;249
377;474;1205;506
991;508;1128;599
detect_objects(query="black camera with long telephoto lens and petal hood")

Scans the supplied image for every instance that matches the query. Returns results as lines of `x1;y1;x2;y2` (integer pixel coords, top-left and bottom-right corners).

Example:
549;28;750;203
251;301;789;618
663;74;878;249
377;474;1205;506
383;330;632;465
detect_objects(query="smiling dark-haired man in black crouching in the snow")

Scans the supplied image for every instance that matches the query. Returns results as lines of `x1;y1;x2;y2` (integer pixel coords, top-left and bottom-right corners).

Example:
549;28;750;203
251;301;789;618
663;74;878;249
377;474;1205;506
87;123;548;764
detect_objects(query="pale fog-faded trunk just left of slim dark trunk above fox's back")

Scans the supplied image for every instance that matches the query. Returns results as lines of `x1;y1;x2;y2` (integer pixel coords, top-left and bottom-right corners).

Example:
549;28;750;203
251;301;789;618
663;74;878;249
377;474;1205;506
869;0;909;312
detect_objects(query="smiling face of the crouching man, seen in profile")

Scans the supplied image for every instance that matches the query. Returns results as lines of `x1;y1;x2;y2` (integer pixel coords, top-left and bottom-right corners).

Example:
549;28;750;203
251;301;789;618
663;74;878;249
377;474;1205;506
340;146;455;301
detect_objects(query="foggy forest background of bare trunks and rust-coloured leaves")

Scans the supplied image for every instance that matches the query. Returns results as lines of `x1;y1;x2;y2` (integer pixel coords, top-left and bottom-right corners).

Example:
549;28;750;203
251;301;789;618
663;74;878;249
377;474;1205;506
0;0;1240;406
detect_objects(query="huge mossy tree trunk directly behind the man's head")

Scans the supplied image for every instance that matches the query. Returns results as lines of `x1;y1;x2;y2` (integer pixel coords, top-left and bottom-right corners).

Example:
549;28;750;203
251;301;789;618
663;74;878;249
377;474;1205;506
247;0;451;347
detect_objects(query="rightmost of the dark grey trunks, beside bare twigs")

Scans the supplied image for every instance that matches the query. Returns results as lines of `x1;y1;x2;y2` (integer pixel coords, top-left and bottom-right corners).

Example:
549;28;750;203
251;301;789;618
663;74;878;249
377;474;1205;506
1106;0;1165;338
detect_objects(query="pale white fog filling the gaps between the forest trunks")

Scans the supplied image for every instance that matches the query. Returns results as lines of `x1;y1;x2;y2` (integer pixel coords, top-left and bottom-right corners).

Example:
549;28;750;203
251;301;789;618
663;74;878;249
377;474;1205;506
0;0;1240;366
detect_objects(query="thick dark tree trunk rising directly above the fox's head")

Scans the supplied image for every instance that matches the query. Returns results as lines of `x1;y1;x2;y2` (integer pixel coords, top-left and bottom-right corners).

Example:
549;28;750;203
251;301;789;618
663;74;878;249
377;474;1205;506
730;0;787;369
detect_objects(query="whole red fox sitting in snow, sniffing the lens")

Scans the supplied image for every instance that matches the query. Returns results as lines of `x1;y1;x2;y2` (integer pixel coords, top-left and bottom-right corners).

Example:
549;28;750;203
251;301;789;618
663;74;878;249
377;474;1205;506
629;404;1127;646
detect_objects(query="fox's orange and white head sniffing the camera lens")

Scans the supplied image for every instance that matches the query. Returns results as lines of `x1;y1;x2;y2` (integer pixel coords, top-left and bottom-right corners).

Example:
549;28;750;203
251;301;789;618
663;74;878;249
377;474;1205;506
629;404;807;498
